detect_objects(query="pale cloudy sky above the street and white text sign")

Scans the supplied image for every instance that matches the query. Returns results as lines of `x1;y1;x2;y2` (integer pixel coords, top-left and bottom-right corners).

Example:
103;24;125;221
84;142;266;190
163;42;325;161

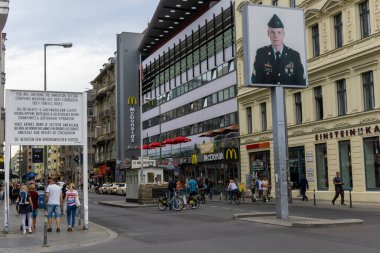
3;0;159;91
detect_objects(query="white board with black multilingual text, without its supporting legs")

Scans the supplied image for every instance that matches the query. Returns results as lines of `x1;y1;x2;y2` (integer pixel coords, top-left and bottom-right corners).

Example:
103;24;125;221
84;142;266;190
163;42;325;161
5;90;87;145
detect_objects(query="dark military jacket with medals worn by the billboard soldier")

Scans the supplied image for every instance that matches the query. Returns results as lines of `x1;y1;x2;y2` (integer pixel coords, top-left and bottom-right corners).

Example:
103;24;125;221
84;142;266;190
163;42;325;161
251;45;305;85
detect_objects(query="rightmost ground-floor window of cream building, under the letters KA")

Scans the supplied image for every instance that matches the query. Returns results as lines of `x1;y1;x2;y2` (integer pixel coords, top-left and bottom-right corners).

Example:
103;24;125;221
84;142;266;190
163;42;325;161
363;136;380;191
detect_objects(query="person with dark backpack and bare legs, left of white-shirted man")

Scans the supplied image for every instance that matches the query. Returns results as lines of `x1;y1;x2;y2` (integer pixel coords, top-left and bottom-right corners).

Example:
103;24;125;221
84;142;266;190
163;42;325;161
16;185;33;234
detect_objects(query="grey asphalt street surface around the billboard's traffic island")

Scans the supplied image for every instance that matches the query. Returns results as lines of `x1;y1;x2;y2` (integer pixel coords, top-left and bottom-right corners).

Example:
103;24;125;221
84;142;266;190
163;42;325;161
54;193;380;253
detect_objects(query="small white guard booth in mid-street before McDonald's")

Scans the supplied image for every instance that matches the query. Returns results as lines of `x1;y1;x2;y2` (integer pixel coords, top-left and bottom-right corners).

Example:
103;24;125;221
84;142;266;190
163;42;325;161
126;158;164;202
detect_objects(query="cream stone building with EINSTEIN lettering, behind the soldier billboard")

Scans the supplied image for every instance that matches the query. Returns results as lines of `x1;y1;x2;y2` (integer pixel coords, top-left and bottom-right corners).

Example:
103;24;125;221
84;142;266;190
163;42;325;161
235;0;380;202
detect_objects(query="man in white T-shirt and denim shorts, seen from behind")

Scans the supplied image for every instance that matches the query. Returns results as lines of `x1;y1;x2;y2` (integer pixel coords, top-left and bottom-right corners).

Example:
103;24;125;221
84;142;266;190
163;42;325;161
46;178;63;232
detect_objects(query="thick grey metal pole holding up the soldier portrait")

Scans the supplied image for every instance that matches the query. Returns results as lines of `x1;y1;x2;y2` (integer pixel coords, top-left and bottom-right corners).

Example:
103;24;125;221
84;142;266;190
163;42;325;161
272;86;289;219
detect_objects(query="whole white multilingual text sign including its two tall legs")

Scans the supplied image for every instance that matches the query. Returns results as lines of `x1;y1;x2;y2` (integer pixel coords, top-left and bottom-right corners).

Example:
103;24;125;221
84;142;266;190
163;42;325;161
3;90;88;232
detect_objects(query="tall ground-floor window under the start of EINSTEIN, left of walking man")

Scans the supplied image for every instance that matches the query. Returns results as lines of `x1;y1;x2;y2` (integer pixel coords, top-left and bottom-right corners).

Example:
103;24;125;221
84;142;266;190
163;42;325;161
315;143;329;190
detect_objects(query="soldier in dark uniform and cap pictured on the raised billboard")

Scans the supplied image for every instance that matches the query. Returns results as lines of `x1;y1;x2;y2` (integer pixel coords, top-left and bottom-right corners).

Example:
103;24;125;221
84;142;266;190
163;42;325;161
251;14;305;85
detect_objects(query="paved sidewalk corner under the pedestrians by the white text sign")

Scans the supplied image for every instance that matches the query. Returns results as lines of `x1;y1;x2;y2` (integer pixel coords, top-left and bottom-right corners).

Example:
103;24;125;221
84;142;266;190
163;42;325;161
0;203;118;253
